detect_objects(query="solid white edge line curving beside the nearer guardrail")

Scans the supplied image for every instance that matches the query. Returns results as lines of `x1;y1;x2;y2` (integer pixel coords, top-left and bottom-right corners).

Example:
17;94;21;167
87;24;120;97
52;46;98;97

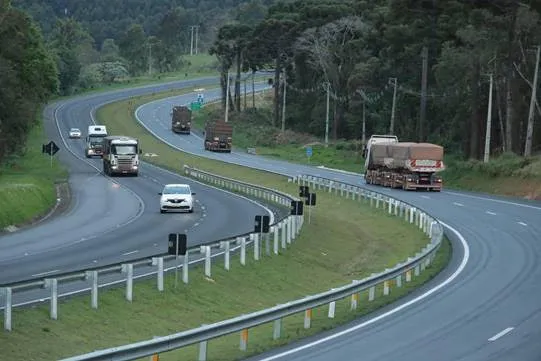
255;221;470;361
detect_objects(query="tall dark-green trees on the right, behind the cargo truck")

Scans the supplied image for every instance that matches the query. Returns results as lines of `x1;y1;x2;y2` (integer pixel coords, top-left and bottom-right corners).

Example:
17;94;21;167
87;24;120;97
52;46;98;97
211;0;541;159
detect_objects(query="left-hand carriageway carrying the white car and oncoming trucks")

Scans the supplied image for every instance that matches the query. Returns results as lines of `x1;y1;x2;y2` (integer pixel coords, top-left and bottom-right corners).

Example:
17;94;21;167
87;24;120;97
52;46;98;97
0;74;271;303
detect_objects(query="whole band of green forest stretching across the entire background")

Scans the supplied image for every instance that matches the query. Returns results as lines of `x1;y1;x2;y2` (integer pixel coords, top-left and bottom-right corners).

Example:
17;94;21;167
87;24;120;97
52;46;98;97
0;0;541;161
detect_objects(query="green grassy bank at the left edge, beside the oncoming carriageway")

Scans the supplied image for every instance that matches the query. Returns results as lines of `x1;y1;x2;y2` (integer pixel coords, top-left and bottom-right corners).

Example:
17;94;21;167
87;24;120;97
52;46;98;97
0;121;67;231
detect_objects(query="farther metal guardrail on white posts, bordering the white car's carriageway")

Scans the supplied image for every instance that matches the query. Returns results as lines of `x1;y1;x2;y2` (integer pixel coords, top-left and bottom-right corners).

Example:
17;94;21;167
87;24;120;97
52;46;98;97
0;166;303;331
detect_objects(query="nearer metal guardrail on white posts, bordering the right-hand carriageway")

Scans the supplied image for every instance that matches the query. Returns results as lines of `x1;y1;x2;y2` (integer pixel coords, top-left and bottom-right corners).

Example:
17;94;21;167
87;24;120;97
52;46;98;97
62;175;444;361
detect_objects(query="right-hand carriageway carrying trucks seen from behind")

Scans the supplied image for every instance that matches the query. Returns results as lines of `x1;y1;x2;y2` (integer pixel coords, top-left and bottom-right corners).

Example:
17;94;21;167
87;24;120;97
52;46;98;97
136;86;541;361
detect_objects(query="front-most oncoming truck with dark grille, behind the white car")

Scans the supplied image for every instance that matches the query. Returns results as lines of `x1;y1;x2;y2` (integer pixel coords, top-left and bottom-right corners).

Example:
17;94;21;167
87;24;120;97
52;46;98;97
103;135;142;177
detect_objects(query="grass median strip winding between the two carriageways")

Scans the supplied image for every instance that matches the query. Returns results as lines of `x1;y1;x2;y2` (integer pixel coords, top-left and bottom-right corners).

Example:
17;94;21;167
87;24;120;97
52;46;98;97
0;88;450;360
